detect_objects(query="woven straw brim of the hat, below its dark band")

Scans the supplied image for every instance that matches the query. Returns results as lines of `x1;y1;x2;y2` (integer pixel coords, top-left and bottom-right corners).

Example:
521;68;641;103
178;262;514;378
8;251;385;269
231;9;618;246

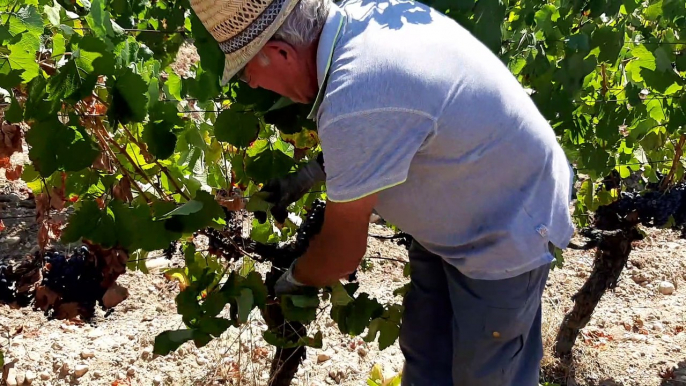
221;0;300;86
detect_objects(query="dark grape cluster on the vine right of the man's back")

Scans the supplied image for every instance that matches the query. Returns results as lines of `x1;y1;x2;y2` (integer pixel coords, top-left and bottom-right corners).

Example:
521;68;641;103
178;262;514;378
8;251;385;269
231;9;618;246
596;183;686;227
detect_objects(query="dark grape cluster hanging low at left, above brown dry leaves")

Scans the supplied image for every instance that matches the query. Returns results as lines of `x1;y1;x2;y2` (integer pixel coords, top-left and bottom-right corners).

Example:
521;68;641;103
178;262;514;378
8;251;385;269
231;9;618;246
41;245;104;306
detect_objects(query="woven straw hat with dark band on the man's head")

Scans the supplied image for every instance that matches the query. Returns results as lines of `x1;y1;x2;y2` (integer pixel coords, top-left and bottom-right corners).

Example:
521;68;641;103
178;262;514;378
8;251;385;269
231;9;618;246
191;0;299;84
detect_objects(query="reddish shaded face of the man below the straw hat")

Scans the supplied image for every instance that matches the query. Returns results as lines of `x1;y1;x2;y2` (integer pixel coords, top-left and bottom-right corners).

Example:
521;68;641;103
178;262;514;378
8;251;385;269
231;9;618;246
241;41;318;103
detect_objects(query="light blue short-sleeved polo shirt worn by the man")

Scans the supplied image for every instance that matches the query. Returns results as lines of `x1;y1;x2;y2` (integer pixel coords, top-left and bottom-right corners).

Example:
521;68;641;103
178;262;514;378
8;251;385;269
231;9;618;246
318;1;573;279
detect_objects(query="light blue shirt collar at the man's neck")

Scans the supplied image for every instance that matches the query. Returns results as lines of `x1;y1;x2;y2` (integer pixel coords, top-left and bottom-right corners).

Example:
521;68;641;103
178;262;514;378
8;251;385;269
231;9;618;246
307;4;345;119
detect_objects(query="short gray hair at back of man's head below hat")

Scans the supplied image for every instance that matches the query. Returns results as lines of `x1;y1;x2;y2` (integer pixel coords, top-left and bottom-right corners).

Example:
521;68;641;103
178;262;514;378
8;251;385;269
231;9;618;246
274;0;332;47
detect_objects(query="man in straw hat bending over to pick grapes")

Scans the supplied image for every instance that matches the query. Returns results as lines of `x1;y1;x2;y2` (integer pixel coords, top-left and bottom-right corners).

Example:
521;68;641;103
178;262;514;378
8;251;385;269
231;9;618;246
191;0;573;386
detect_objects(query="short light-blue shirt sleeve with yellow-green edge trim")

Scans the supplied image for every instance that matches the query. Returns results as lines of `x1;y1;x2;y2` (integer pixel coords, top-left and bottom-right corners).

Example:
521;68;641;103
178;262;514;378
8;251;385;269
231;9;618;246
319;109;436;202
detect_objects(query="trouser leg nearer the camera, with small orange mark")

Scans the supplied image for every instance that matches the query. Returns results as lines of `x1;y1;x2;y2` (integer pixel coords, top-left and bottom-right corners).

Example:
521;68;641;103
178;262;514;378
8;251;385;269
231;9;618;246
445;264;547;386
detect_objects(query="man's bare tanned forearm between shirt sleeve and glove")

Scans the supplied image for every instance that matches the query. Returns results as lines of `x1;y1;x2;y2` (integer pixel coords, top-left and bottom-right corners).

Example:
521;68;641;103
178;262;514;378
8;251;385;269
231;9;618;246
293;194;377;287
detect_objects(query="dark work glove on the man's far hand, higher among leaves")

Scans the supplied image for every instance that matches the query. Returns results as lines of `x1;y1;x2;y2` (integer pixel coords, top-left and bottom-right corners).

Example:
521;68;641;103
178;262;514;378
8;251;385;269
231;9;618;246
255;154;326;224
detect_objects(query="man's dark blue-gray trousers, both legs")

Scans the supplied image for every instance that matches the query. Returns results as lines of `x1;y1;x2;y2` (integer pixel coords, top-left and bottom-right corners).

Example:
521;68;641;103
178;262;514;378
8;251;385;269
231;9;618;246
400;242;550;386
